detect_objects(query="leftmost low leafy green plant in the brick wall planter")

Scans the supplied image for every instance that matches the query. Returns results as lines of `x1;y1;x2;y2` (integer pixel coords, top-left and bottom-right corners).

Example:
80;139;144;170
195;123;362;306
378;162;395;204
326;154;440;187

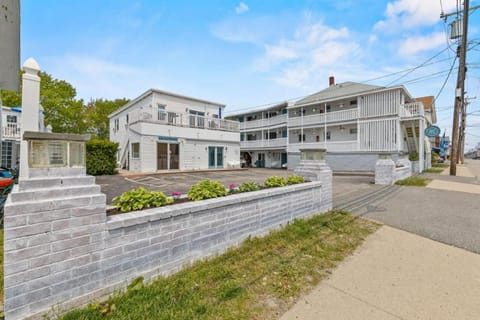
112;187;173;212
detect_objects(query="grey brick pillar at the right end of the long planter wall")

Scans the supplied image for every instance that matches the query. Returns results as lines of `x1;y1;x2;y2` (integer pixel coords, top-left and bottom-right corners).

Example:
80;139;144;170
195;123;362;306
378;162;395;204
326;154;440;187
294;149;333;212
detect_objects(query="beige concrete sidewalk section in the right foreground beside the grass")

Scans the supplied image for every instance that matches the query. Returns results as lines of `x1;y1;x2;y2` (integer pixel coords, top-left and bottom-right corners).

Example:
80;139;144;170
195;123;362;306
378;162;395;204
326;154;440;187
280;226;480;320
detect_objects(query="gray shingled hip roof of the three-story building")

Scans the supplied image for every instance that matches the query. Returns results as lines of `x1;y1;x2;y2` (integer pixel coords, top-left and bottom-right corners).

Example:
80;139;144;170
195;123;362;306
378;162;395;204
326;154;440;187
295;81;385;105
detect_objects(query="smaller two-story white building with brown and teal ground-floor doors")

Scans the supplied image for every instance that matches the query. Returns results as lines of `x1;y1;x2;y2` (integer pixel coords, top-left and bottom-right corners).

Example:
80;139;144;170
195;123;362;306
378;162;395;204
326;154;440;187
109;89;240;172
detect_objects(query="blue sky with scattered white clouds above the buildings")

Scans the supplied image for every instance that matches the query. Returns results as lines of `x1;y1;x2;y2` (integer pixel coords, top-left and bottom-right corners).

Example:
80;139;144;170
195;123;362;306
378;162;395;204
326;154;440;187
21;0;480;150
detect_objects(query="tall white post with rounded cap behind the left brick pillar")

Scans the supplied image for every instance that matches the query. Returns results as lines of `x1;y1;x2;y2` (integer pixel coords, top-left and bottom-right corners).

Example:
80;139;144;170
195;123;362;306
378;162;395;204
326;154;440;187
20;58;40;178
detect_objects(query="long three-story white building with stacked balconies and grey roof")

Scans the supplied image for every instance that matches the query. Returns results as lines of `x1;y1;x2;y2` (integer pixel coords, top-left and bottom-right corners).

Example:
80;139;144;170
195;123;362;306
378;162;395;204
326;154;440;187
228;77;436;171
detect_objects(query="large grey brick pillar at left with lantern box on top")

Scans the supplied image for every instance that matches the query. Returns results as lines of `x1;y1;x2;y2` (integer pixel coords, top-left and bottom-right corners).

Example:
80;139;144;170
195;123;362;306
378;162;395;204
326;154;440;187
4;131;106;320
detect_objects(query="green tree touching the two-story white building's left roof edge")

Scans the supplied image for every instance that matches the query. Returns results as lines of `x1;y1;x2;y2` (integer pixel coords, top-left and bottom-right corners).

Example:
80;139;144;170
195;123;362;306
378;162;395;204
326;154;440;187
87;98;130;140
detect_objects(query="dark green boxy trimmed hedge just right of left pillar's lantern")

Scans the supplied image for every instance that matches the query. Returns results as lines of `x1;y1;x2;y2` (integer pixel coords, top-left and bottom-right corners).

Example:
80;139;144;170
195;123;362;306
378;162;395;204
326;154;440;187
86;140;118;176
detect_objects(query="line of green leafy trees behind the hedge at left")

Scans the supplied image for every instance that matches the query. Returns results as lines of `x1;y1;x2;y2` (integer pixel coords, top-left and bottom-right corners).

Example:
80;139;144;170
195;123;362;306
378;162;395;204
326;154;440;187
0;71;129;140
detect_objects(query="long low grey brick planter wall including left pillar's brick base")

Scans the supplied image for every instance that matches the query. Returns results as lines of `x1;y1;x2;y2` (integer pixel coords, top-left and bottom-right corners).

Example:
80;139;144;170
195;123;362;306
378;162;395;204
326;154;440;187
4;172;331;319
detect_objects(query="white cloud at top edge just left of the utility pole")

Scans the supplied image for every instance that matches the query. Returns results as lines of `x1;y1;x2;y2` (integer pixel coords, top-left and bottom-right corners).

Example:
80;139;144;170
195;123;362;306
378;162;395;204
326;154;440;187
374;0;456;33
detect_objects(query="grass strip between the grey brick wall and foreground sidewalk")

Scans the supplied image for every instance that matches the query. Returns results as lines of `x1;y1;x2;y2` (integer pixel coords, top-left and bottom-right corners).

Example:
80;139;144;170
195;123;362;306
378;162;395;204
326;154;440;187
60;212;378;320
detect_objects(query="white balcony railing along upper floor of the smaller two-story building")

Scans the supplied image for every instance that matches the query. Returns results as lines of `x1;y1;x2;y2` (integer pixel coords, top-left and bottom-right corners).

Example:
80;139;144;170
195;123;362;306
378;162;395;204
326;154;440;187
130;111;240;132
